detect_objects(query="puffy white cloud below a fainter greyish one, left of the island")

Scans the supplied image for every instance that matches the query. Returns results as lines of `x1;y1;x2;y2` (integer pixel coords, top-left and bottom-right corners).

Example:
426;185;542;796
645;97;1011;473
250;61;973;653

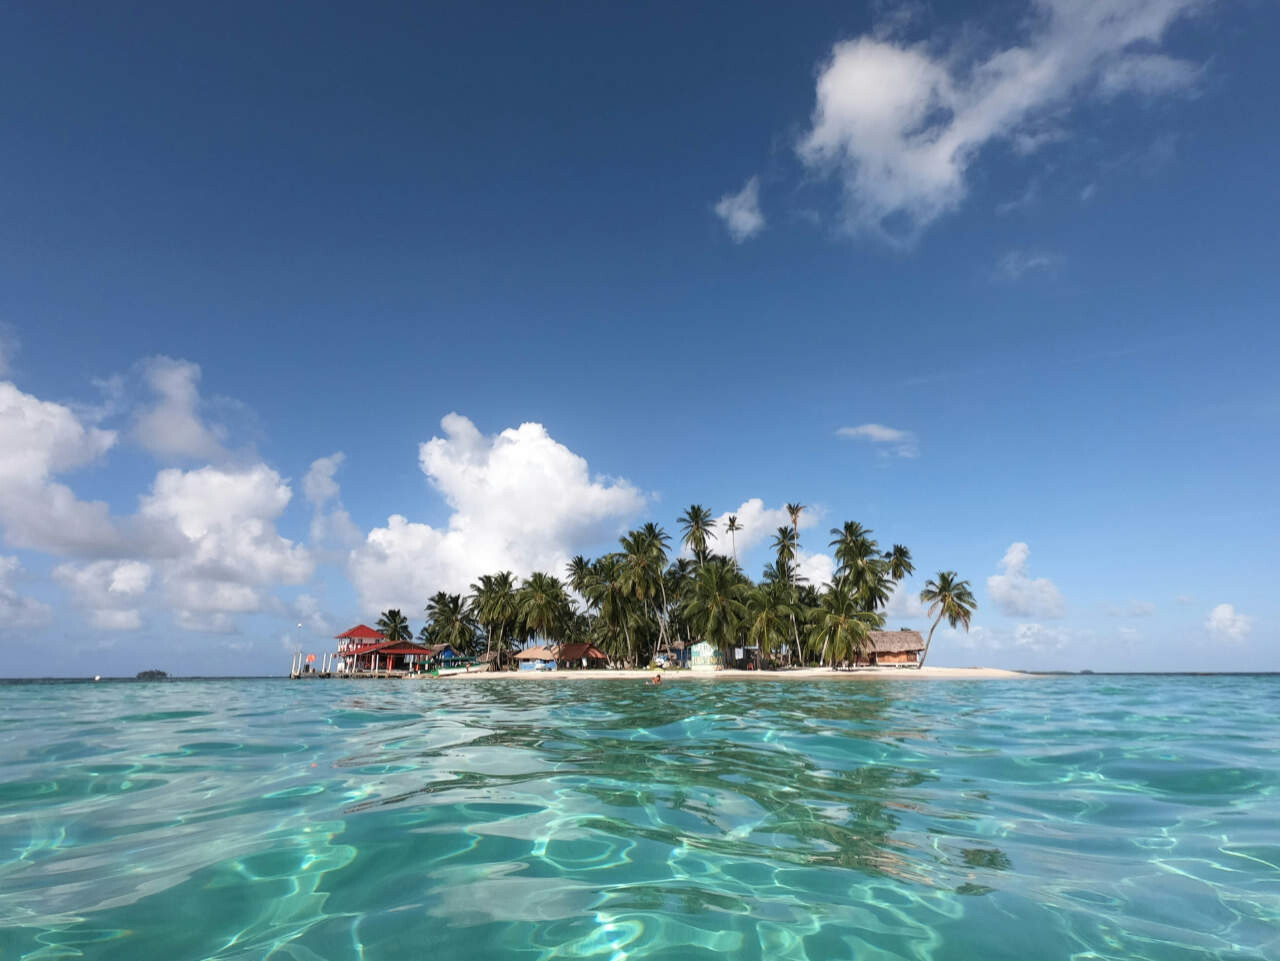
141;463;315;631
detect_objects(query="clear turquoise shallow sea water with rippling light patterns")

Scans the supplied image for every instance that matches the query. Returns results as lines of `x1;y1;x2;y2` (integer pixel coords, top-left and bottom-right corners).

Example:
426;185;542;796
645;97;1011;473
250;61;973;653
0;677;1280;961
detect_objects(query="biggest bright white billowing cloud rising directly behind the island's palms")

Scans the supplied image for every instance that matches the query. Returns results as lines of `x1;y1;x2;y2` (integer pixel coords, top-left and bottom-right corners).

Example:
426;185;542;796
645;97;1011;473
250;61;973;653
348;413;645;610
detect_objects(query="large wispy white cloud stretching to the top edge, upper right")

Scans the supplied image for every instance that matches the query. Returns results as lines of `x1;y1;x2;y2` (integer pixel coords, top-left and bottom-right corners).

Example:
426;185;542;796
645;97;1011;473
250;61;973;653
797;0;1207;242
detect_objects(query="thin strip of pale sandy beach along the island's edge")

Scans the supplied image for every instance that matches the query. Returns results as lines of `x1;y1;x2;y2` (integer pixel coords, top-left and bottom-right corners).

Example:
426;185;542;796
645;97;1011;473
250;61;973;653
436;665;1036;682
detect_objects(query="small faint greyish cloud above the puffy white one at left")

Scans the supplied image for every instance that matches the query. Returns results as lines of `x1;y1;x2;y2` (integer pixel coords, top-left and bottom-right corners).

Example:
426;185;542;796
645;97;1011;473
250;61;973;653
132;357;227;461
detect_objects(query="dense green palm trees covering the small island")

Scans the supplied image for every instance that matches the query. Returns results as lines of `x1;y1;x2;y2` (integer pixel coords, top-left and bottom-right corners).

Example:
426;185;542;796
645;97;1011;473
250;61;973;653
378;503;977;667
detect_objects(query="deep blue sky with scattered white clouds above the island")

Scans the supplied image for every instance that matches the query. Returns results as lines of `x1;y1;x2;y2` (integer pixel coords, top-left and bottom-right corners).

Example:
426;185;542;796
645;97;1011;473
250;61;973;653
0;0;1280;676
